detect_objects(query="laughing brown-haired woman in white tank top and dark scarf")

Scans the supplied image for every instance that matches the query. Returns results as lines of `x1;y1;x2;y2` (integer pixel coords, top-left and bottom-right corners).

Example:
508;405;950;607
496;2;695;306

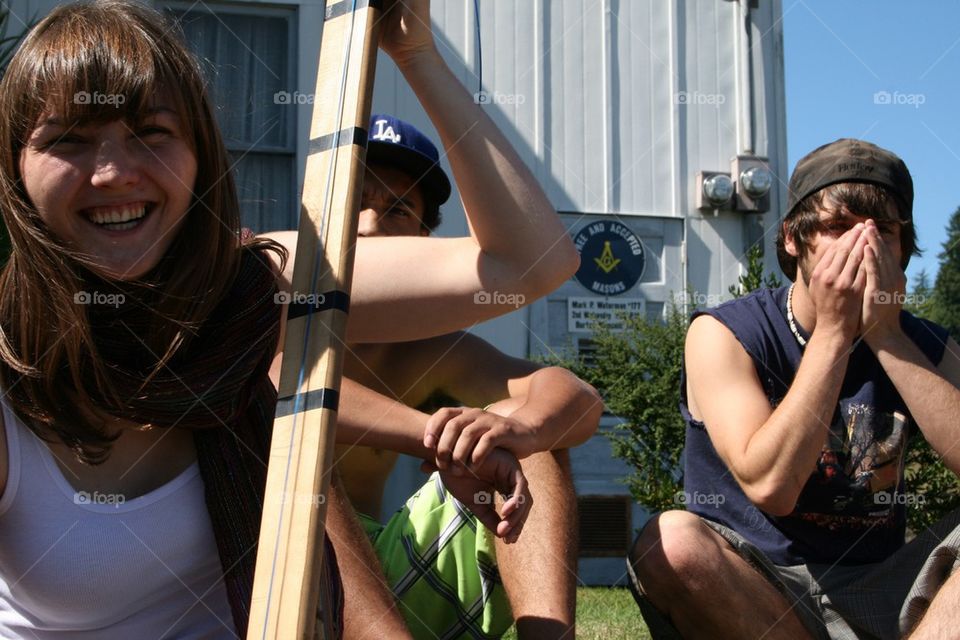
0;0;577;639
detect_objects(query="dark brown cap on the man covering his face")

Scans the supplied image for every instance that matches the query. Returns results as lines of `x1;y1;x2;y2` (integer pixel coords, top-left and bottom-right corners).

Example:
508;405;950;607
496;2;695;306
786;138;913;220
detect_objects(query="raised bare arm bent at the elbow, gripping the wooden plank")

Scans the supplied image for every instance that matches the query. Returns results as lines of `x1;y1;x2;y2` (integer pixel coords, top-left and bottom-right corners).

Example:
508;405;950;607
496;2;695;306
255;0;580;342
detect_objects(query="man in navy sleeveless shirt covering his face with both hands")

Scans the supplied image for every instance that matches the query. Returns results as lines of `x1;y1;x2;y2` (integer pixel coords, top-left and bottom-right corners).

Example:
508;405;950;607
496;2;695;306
629;139;960;638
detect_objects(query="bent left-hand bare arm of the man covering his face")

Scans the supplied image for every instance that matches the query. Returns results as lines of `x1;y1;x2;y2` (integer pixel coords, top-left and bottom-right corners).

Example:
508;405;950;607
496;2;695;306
684;316;849;515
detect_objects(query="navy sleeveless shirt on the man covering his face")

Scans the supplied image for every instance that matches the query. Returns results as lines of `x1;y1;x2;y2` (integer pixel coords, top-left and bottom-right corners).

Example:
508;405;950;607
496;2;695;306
680;287;948;565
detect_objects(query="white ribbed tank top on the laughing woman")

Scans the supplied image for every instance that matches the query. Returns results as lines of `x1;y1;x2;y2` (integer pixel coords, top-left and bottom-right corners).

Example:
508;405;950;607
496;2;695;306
0;402;237;640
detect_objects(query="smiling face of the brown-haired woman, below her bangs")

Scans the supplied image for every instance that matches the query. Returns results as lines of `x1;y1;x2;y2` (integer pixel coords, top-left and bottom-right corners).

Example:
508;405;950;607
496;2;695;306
20;98;197;280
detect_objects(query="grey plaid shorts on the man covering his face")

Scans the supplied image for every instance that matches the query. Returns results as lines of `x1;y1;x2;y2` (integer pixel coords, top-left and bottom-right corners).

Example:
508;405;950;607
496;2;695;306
627;509;960;640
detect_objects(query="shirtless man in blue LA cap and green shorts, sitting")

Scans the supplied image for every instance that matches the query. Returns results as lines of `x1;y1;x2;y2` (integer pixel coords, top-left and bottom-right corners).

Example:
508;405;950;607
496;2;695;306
337;116;602;638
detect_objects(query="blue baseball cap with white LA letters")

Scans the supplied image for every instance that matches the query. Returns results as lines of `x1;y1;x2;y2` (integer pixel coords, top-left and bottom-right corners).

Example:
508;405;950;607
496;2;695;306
367;114;450;206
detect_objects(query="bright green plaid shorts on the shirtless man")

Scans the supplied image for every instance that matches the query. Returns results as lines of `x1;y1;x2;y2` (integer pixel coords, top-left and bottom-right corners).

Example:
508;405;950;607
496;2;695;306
358;473;513;640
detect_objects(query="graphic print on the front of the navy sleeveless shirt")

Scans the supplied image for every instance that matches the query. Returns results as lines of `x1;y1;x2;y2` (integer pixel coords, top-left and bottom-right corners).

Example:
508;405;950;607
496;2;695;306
796;401;909;529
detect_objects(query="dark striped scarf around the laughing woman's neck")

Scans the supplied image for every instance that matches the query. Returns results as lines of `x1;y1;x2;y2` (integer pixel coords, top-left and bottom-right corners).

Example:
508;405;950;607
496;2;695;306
95;249;343;638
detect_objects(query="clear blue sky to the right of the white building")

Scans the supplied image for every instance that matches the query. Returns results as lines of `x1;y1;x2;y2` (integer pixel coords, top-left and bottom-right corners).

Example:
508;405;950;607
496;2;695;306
782;0;960;283
